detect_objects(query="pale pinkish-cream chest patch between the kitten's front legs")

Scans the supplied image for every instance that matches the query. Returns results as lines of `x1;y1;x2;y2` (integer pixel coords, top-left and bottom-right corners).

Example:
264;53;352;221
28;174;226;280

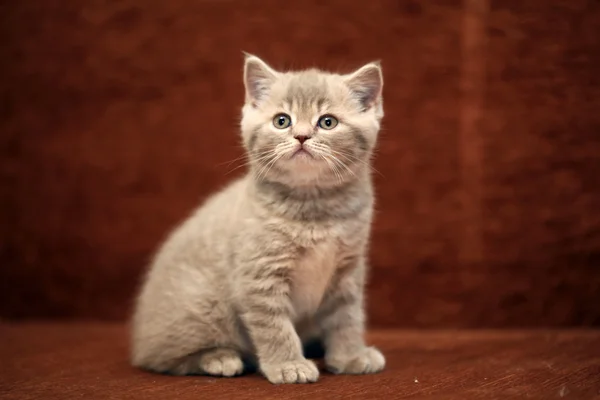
291;240;341;318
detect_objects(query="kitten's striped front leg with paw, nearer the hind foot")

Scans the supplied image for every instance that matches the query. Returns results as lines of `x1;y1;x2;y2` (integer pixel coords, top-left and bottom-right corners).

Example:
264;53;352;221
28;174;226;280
238;252;319;384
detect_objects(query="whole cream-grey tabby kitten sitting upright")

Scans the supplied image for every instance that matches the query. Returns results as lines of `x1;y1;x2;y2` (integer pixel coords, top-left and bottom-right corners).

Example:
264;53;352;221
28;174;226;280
132;55;385;383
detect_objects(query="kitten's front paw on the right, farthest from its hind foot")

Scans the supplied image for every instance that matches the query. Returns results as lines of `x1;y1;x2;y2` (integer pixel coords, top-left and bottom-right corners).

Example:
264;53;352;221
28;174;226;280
325;347;385;374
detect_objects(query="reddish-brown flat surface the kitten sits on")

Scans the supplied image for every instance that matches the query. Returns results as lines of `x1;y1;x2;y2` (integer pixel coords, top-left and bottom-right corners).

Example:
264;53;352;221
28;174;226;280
0;323;600;400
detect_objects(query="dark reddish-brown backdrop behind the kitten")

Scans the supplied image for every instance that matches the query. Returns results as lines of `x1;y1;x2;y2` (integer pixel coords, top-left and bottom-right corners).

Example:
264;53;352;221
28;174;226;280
0;0;600;327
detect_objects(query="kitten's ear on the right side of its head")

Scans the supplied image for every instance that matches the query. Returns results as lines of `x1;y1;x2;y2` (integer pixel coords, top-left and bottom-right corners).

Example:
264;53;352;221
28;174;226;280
345;62;383;110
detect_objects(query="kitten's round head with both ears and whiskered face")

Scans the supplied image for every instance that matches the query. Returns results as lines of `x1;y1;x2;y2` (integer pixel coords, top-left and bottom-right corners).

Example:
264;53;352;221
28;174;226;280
241;55;383;186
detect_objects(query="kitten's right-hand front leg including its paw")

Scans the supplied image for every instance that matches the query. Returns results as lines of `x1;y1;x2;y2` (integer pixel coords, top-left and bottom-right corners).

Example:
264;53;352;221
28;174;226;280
317;259;385;374
